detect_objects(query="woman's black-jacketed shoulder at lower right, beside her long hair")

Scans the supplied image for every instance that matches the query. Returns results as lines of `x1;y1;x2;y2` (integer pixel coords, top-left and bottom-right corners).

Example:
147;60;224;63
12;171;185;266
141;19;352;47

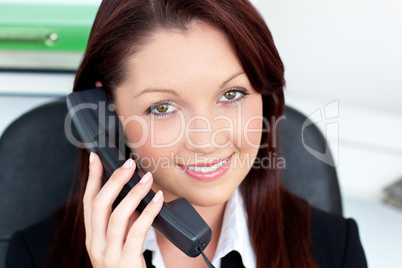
311;208;367;268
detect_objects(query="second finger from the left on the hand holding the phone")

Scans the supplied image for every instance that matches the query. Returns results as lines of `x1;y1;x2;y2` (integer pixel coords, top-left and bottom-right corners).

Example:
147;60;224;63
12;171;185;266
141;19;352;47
91;159;135;245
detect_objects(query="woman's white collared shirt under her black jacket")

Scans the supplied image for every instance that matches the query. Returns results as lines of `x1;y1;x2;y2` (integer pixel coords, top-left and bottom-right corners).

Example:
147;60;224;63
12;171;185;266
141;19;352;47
142;189;256;268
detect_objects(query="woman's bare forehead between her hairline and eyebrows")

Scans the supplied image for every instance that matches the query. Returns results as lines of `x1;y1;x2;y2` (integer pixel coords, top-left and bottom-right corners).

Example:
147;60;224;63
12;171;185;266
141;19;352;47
124;22;243;91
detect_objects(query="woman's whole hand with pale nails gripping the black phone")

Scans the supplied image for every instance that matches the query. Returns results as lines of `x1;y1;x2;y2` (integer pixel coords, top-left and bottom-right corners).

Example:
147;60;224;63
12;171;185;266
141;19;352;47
83;153;163;268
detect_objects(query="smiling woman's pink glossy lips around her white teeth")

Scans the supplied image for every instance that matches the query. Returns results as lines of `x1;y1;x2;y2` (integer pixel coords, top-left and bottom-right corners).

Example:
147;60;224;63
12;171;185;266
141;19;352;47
178;154;233;182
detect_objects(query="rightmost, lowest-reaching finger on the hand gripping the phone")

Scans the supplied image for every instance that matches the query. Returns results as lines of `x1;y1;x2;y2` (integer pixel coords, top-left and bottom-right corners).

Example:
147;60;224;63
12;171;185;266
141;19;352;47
122;191;164;259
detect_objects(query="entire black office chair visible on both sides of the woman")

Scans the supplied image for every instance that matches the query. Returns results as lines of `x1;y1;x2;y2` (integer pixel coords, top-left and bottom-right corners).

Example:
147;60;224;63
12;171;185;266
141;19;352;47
0;99;342;268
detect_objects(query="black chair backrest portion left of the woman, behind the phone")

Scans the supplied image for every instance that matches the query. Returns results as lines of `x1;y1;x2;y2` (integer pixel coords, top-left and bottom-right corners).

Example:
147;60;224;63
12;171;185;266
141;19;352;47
0;99;77;267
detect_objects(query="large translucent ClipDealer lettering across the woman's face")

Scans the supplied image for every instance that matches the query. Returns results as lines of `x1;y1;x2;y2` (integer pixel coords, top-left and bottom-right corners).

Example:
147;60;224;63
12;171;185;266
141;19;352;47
64;102;276;150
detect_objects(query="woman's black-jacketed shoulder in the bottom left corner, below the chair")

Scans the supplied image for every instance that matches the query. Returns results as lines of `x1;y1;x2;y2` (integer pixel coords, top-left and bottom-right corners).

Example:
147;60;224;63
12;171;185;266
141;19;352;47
6;218;54;267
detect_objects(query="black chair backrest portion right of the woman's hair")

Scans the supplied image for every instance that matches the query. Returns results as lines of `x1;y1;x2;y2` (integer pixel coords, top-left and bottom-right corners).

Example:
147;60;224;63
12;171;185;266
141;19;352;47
278;107;342;215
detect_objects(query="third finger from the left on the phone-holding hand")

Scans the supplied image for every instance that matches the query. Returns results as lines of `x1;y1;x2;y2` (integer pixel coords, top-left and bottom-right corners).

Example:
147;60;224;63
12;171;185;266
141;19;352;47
107;172;153;256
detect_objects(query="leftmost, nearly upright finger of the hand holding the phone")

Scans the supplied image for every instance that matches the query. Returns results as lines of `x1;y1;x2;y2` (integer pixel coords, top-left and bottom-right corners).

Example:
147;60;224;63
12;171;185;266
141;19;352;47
83;153;103;244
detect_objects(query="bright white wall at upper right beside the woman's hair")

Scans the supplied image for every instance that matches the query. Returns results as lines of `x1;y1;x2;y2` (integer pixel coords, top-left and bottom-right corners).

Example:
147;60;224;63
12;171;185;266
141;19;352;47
258;0;402;115
